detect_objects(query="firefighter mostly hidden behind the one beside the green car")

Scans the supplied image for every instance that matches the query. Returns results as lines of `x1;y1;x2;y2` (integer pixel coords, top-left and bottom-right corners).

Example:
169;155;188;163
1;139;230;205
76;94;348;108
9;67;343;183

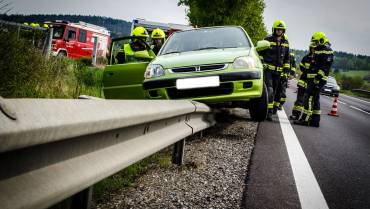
278;53;296;110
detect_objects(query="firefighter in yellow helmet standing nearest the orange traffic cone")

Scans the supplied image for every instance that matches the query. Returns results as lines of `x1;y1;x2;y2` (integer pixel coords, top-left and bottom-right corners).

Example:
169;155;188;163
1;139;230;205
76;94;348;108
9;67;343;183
294;32;334;127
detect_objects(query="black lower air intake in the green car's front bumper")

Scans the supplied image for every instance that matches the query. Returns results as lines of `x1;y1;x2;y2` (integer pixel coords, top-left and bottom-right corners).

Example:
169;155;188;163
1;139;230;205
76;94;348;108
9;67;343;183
167;83;234;99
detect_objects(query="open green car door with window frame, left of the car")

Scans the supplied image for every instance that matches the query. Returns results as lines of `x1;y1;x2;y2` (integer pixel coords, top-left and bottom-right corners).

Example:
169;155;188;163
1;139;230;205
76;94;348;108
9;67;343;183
103;37;155;99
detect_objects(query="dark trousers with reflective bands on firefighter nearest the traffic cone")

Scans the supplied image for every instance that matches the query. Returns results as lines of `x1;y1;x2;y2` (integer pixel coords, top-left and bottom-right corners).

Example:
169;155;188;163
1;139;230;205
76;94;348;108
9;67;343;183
301;82;321;125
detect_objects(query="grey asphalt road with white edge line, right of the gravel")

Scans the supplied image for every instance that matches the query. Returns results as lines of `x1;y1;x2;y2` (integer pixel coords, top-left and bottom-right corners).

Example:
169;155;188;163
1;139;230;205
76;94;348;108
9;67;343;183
244;80;370;209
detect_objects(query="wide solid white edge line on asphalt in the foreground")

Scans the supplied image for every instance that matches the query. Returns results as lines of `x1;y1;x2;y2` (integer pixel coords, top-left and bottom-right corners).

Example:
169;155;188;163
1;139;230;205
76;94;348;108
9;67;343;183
278;110;329;209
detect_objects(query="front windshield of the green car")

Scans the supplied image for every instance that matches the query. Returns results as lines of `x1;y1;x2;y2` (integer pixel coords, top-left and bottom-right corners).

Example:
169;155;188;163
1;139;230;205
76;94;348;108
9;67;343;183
160;27;251;55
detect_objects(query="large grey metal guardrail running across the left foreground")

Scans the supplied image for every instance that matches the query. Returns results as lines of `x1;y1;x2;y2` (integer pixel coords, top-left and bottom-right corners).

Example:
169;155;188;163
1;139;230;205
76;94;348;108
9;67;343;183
0;98;215;209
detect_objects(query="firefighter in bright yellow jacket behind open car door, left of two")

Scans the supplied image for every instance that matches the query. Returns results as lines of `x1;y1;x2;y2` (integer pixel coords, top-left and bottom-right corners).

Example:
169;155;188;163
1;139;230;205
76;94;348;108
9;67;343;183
115;26;155;64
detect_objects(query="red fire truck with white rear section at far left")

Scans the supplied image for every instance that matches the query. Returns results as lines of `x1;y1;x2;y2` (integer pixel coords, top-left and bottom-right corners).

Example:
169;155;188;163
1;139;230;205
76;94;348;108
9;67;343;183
48;20;110;59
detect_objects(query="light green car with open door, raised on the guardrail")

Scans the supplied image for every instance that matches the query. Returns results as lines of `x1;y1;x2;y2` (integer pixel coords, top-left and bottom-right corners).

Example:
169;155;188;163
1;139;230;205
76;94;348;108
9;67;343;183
104;26;268;121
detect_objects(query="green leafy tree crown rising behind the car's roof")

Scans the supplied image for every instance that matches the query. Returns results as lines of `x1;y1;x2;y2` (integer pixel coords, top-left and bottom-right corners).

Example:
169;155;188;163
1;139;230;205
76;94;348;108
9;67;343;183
179;0;267;43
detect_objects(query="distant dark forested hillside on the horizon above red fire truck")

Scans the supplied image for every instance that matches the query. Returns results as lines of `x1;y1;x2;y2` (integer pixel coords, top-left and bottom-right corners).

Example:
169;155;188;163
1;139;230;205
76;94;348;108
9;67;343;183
0;14;131;38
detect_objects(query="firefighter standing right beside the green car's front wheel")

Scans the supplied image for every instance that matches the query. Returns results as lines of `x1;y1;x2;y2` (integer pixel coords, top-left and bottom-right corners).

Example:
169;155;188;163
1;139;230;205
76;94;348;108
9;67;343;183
259;20;290;121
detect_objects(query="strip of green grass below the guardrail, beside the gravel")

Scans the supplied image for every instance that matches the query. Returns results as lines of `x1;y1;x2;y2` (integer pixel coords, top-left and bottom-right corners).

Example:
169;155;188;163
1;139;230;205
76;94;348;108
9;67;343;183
93;149;171;202
